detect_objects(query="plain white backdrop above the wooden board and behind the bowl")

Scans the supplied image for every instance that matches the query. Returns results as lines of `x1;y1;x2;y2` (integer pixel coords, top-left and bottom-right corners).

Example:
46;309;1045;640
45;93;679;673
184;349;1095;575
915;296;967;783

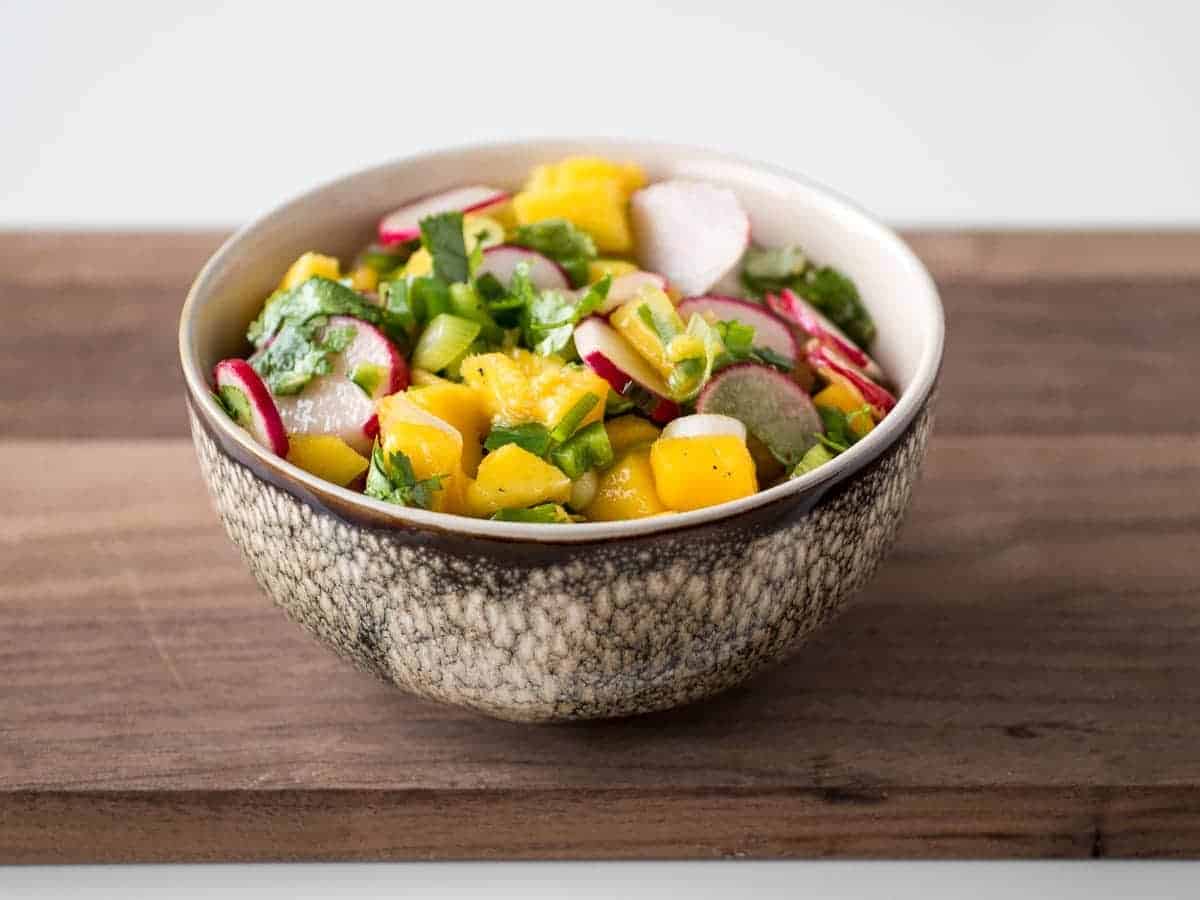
0;0;1200;227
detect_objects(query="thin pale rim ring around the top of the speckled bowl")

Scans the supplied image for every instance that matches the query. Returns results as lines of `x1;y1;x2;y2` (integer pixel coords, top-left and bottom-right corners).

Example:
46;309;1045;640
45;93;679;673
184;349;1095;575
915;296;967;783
179;136;946;544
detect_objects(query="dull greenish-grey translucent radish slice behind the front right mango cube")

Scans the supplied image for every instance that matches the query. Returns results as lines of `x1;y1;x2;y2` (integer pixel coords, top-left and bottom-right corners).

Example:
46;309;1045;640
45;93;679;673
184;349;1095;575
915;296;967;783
696;362;824;467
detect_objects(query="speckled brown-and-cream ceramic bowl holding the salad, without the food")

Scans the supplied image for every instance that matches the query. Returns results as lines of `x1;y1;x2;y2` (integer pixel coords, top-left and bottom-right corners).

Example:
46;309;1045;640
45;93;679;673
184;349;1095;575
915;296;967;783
180;140;943;721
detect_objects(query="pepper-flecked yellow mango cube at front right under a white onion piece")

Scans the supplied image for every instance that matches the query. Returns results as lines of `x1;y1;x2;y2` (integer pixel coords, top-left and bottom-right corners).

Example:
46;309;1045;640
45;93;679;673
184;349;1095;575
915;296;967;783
650;434;758;511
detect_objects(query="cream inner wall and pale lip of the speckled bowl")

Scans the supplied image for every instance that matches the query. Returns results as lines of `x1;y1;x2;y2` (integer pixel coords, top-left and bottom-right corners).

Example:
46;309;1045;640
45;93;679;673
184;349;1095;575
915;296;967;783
180;139;943;541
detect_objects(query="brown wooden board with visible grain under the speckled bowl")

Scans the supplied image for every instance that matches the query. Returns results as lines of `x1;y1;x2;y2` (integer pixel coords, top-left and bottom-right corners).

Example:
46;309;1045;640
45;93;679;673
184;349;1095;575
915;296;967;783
0;233;1200;862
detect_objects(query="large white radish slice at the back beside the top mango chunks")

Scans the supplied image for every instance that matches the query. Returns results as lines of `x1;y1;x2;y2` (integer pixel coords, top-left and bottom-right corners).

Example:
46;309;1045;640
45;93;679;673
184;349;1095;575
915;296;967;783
630;181;750;295
